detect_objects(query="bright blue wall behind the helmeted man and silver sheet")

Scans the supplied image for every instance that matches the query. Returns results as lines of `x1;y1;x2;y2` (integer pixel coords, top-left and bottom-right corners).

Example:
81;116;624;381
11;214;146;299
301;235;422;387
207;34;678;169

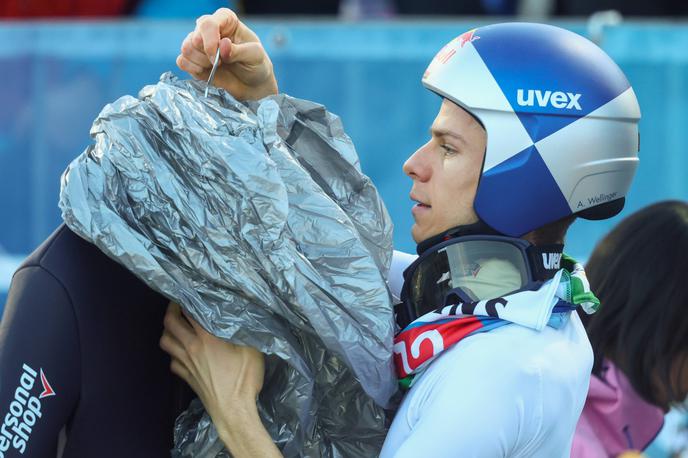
0;20;688;307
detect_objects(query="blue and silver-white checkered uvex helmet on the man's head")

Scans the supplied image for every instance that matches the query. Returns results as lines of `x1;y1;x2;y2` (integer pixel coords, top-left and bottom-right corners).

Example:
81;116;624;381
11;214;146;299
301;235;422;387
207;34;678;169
423;23;640;237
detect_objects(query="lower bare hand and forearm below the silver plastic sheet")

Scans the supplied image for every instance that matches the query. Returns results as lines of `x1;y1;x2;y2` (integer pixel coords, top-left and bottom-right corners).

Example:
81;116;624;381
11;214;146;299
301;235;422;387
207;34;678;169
160;303;282;458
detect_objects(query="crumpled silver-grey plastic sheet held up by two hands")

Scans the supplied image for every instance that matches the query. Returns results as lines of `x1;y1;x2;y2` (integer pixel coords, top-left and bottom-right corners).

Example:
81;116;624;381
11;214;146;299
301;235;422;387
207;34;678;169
60;74;396;457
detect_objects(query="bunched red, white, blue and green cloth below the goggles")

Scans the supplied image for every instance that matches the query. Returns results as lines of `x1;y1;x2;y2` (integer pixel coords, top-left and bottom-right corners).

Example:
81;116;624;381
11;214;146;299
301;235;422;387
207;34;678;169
394;257;600;389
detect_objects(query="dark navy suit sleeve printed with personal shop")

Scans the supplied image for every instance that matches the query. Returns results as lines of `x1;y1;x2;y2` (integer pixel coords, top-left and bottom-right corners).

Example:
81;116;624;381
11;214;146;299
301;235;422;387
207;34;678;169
0;266;80;458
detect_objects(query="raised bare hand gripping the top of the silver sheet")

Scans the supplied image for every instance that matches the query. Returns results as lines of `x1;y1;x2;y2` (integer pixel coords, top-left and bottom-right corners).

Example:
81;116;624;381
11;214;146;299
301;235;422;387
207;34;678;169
177;8;277;100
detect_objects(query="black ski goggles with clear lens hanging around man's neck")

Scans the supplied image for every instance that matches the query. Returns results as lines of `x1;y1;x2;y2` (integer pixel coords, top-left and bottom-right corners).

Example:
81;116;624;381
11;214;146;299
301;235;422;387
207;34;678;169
396;236;563;328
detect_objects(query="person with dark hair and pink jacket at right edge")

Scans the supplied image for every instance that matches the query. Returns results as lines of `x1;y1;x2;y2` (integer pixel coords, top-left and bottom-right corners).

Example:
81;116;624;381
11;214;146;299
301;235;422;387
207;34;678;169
571;201;688;458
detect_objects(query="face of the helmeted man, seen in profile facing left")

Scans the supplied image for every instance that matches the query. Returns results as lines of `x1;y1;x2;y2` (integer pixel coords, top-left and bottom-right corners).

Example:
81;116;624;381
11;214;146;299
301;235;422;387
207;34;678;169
404;99;486;243
